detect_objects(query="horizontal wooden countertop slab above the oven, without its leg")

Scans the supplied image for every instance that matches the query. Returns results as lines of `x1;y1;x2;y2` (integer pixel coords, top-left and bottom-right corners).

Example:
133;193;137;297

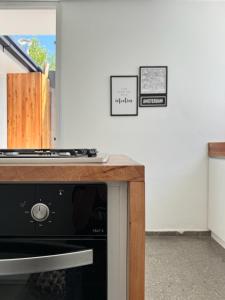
0;155;144;182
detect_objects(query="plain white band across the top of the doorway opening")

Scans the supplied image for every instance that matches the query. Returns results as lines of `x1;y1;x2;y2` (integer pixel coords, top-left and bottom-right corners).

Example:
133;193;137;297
0;9;56;35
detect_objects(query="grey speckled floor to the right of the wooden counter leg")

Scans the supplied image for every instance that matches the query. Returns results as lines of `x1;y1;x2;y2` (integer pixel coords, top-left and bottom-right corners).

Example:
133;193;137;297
145;236;225;300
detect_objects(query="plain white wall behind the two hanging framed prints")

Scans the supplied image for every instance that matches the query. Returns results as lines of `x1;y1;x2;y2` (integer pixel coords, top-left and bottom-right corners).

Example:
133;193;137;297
58;0;225;230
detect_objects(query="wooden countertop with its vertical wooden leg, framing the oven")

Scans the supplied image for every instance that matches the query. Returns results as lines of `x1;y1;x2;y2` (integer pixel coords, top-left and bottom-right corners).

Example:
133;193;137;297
0;155;145;300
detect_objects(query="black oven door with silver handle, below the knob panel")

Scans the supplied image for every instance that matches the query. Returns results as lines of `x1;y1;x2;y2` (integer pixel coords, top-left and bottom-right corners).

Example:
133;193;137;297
0;239;107;300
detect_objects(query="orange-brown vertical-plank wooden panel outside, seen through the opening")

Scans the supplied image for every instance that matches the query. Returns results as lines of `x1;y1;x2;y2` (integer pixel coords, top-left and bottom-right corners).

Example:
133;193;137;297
7;73;51;149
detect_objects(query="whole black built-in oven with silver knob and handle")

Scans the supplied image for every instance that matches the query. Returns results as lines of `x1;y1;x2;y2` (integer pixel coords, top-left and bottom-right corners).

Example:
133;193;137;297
0;183;107;300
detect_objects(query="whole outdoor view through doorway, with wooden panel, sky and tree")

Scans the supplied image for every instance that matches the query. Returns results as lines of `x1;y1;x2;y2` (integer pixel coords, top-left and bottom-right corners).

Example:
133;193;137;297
0;9;57;149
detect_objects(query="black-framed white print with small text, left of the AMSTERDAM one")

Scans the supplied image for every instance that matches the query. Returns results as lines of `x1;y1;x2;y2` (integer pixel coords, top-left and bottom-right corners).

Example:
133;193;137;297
110;76;138;116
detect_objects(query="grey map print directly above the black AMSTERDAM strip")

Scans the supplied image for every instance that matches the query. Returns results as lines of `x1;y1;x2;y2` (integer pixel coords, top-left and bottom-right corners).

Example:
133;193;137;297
140;66;168;96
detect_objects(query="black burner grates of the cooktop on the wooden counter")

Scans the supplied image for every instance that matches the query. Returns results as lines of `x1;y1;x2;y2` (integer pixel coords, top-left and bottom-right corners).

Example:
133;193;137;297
0;149;97;158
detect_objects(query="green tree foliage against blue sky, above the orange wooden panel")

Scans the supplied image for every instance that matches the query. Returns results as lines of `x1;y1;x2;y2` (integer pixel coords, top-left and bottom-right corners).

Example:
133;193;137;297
29;38;55;71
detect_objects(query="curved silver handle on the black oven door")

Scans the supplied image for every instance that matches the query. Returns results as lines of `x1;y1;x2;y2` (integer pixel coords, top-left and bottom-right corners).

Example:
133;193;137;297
0;249;93;275
